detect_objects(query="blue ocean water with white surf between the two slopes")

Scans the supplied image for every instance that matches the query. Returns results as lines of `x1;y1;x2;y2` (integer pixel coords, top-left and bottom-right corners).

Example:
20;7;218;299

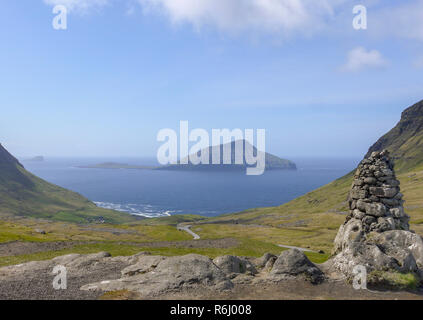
22;158;360;217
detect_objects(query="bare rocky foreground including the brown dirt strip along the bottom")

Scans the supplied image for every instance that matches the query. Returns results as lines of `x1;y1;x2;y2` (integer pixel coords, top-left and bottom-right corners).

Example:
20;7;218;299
0;249;423;299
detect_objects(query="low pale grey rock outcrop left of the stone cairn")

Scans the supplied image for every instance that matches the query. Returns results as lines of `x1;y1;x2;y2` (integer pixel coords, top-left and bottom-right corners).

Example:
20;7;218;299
0;250;324;299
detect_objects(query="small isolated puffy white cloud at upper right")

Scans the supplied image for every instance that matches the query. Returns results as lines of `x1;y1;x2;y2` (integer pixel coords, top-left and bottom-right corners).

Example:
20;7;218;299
341;47;388;72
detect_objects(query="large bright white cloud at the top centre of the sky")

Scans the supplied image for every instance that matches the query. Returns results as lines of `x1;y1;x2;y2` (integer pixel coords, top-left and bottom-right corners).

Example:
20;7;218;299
138;0;345;34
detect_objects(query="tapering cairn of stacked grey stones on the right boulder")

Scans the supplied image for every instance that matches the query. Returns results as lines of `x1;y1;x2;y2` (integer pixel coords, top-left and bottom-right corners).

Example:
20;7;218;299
347;150;410;233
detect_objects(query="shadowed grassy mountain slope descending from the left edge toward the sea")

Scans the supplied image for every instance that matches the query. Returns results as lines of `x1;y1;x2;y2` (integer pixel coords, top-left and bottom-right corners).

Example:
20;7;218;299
0;144;134;223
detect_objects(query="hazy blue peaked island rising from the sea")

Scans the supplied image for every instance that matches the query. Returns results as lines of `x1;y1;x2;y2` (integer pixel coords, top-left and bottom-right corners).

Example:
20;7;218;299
156;140;297;171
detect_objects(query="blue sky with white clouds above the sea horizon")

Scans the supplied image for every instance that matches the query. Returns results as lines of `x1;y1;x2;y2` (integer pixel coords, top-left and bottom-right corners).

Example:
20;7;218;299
0;0;423;157
